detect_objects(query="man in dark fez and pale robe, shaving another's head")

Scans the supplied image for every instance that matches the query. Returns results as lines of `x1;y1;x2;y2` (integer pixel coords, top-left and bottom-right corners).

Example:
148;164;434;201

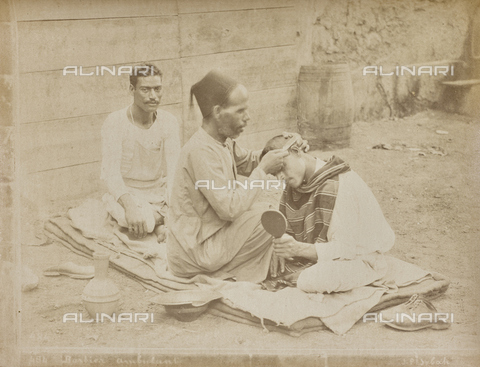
167;71;300;282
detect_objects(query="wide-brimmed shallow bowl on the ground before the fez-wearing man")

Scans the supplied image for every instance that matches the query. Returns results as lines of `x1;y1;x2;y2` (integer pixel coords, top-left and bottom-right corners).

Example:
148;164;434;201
151;290;222;322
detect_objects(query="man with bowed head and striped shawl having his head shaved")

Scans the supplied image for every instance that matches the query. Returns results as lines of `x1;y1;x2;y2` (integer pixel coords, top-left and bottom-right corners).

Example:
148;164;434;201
263;136;395;293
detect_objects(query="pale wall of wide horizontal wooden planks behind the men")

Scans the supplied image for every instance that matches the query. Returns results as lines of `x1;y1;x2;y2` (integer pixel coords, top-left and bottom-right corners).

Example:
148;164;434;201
15;0;298;205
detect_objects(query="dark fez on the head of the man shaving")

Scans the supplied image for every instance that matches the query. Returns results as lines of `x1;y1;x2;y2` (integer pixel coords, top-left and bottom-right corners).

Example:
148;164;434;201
190;70;238;118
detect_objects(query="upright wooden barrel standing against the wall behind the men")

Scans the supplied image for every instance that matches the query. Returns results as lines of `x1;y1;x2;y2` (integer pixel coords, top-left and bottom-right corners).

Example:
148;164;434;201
297;63;354;150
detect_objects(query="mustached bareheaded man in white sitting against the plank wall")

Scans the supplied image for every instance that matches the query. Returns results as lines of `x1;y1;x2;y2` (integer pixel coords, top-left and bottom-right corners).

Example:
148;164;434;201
101;64;180;240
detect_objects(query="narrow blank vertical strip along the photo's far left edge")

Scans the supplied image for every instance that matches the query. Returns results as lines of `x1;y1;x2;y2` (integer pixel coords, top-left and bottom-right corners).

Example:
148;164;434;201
0;0;21;366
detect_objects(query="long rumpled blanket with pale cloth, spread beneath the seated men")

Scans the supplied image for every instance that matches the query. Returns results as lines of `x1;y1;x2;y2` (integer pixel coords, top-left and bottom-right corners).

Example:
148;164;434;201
45;204;449;335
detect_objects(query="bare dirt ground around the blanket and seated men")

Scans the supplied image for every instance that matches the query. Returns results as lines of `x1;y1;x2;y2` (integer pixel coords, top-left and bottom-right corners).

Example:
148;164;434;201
21;111;480;366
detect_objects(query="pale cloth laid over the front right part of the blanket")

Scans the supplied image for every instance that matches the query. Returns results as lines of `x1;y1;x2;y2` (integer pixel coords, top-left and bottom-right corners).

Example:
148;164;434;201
210;256;432;334
